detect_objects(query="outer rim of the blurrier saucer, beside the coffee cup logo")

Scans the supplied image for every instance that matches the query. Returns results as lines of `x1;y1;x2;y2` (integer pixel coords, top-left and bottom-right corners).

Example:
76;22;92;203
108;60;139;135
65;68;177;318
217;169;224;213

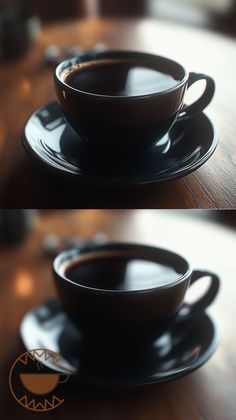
19;298;220;388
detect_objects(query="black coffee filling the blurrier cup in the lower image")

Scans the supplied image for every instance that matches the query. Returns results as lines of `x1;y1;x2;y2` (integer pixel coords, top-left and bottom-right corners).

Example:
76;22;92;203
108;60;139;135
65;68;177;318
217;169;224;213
65;252;180;290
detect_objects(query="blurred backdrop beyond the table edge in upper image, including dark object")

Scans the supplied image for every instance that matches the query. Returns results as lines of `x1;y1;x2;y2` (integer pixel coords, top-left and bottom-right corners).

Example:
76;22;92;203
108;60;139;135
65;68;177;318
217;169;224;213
0;0;236;57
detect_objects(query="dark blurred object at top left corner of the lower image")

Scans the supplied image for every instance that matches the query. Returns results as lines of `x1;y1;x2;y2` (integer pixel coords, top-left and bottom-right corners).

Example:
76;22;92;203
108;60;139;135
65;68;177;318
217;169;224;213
0;209;36;247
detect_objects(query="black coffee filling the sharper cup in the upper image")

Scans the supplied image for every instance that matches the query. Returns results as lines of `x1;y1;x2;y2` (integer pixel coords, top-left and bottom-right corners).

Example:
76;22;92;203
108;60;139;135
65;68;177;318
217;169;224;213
65;58;178;96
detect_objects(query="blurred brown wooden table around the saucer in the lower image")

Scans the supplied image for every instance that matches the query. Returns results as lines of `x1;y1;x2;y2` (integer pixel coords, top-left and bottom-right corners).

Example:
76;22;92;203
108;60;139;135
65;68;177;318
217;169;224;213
0;210;236;420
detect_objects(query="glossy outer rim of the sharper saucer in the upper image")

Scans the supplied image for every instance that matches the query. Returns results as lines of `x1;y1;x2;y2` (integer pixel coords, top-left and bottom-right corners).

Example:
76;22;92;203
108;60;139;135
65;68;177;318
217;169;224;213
21;100;219;188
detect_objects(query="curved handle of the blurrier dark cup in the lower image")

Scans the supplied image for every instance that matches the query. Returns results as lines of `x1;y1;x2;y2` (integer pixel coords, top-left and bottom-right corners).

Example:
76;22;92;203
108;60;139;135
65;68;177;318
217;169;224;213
179;270;220;317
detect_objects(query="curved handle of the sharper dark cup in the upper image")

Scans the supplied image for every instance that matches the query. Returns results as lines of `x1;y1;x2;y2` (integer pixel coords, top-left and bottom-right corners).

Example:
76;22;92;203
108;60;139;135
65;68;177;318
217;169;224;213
178;73;215;119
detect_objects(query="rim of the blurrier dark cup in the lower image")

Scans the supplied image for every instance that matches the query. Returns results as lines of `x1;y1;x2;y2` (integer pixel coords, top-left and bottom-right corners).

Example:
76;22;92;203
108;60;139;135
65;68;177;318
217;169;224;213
53;242;193;296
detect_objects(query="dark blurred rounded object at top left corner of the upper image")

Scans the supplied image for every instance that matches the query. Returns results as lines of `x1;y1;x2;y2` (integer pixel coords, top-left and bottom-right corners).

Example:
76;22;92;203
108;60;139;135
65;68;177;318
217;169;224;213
0;0;40;58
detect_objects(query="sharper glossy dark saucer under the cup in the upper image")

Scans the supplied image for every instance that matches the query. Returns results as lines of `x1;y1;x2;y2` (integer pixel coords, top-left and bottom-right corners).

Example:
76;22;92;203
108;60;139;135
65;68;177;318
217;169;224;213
22;102;218;186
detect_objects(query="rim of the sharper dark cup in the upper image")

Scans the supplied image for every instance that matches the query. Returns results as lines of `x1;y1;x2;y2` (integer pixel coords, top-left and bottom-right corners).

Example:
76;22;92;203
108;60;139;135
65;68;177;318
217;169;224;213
54;50;189;101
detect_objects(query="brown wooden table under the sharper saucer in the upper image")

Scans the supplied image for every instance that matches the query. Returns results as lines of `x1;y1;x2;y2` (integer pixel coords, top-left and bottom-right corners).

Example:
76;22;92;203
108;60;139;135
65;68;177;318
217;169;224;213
0;19;236;208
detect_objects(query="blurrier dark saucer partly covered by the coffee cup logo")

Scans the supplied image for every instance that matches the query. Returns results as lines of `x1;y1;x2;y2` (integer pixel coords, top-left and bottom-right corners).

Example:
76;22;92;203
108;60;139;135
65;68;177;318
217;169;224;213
20;300;218;386
